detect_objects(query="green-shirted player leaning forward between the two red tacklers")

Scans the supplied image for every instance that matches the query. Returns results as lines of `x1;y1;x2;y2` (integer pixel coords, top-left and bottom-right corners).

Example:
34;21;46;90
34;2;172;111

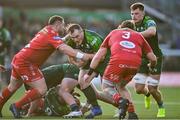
63;24;103;118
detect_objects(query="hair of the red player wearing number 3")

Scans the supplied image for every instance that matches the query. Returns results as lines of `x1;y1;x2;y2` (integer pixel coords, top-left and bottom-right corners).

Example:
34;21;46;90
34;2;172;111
118;20;135;30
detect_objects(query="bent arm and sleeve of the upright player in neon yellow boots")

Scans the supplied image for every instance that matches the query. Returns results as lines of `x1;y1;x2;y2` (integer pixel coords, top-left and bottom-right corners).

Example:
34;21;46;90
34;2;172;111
141;20;156;38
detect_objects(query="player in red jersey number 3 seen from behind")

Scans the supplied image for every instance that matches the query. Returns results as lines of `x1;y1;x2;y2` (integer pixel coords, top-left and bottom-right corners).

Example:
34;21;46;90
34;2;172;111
84;21;157;119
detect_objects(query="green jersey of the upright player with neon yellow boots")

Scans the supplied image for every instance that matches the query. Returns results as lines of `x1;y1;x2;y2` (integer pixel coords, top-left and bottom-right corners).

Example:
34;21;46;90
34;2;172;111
136;16;162;57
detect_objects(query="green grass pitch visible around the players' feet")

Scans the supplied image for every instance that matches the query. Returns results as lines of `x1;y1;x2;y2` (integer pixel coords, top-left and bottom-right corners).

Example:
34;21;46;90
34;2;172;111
2;87;180;119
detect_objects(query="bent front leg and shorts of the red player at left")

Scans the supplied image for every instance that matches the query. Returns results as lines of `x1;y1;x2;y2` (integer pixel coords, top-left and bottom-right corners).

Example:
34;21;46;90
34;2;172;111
10;66;47;118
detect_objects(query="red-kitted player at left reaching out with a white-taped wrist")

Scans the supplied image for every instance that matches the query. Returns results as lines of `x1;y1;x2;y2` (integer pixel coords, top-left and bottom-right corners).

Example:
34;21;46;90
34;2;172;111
0;15;92;118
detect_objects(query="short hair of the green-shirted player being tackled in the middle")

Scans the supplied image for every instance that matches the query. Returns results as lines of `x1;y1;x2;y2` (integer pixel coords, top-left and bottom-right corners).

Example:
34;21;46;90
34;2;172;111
66;23;82;33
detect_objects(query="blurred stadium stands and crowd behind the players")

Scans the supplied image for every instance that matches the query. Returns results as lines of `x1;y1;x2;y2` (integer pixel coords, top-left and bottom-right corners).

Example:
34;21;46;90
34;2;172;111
0;0;180;119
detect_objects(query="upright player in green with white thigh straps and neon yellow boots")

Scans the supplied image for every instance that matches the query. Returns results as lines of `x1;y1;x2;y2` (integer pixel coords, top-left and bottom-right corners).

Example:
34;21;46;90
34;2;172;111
130;2;165;117
